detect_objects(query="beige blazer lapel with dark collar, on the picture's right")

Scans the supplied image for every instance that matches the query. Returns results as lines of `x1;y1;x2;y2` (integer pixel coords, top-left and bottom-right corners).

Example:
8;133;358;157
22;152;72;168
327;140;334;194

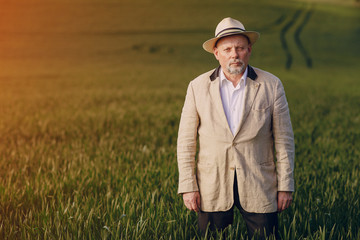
234;66;260;137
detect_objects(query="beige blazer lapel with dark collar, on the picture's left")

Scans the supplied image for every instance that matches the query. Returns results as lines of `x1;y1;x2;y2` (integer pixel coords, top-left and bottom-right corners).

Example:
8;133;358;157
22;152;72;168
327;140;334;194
209;67;232;135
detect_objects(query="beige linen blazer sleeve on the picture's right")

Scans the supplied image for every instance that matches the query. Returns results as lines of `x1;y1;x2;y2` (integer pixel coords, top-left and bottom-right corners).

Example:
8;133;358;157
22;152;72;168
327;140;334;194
273;80;295;192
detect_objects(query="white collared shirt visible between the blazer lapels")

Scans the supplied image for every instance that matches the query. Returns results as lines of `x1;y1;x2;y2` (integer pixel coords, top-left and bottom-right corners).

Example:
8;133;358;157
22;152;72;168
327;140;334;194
220;68;248;136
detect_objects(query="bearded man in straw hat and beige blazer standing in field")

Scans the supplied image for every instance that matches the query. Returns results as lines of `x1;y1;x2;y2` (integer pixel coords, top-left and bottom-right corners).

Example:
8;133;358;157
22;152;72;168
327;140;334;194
177;18;294;238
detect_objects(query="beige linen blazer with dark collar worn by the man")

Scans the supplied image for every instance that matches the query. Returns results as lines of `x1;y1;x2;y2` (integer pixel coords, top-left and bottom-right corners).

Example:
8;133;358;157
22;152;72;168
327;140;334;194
177;66;295;213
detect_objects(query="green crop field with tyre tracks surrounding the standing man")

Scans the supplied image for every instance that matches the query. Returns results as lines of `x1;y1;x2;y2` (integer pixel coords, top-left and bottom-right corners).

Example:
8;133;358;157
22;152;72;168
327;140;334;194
0;0;360;239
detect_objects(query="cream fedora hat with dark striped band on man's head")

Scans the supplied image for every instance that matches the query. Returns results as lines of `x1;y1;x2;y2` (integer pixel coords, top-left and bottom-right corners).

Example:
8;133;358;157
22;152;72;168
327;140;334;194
203;17;260;53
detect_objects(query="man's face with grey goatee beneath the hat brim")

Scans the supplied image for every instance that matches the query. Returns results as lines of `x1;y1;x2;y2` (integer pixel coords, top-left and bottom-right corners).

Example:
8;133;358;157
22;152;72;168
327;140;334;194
214;35;251;75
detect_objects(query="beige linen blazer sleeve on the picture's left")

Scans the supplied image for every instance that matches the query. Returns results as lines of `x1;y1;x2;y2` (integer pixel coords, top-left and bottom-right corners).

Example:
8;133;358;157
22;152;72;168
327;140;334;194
177;82;199;194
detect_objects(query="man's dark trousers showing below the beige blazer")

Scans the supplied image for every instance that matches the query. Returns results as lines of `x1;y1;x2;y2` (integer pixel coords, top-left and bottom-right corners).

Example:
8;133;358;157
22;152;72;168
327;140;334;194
198;174;278;239
